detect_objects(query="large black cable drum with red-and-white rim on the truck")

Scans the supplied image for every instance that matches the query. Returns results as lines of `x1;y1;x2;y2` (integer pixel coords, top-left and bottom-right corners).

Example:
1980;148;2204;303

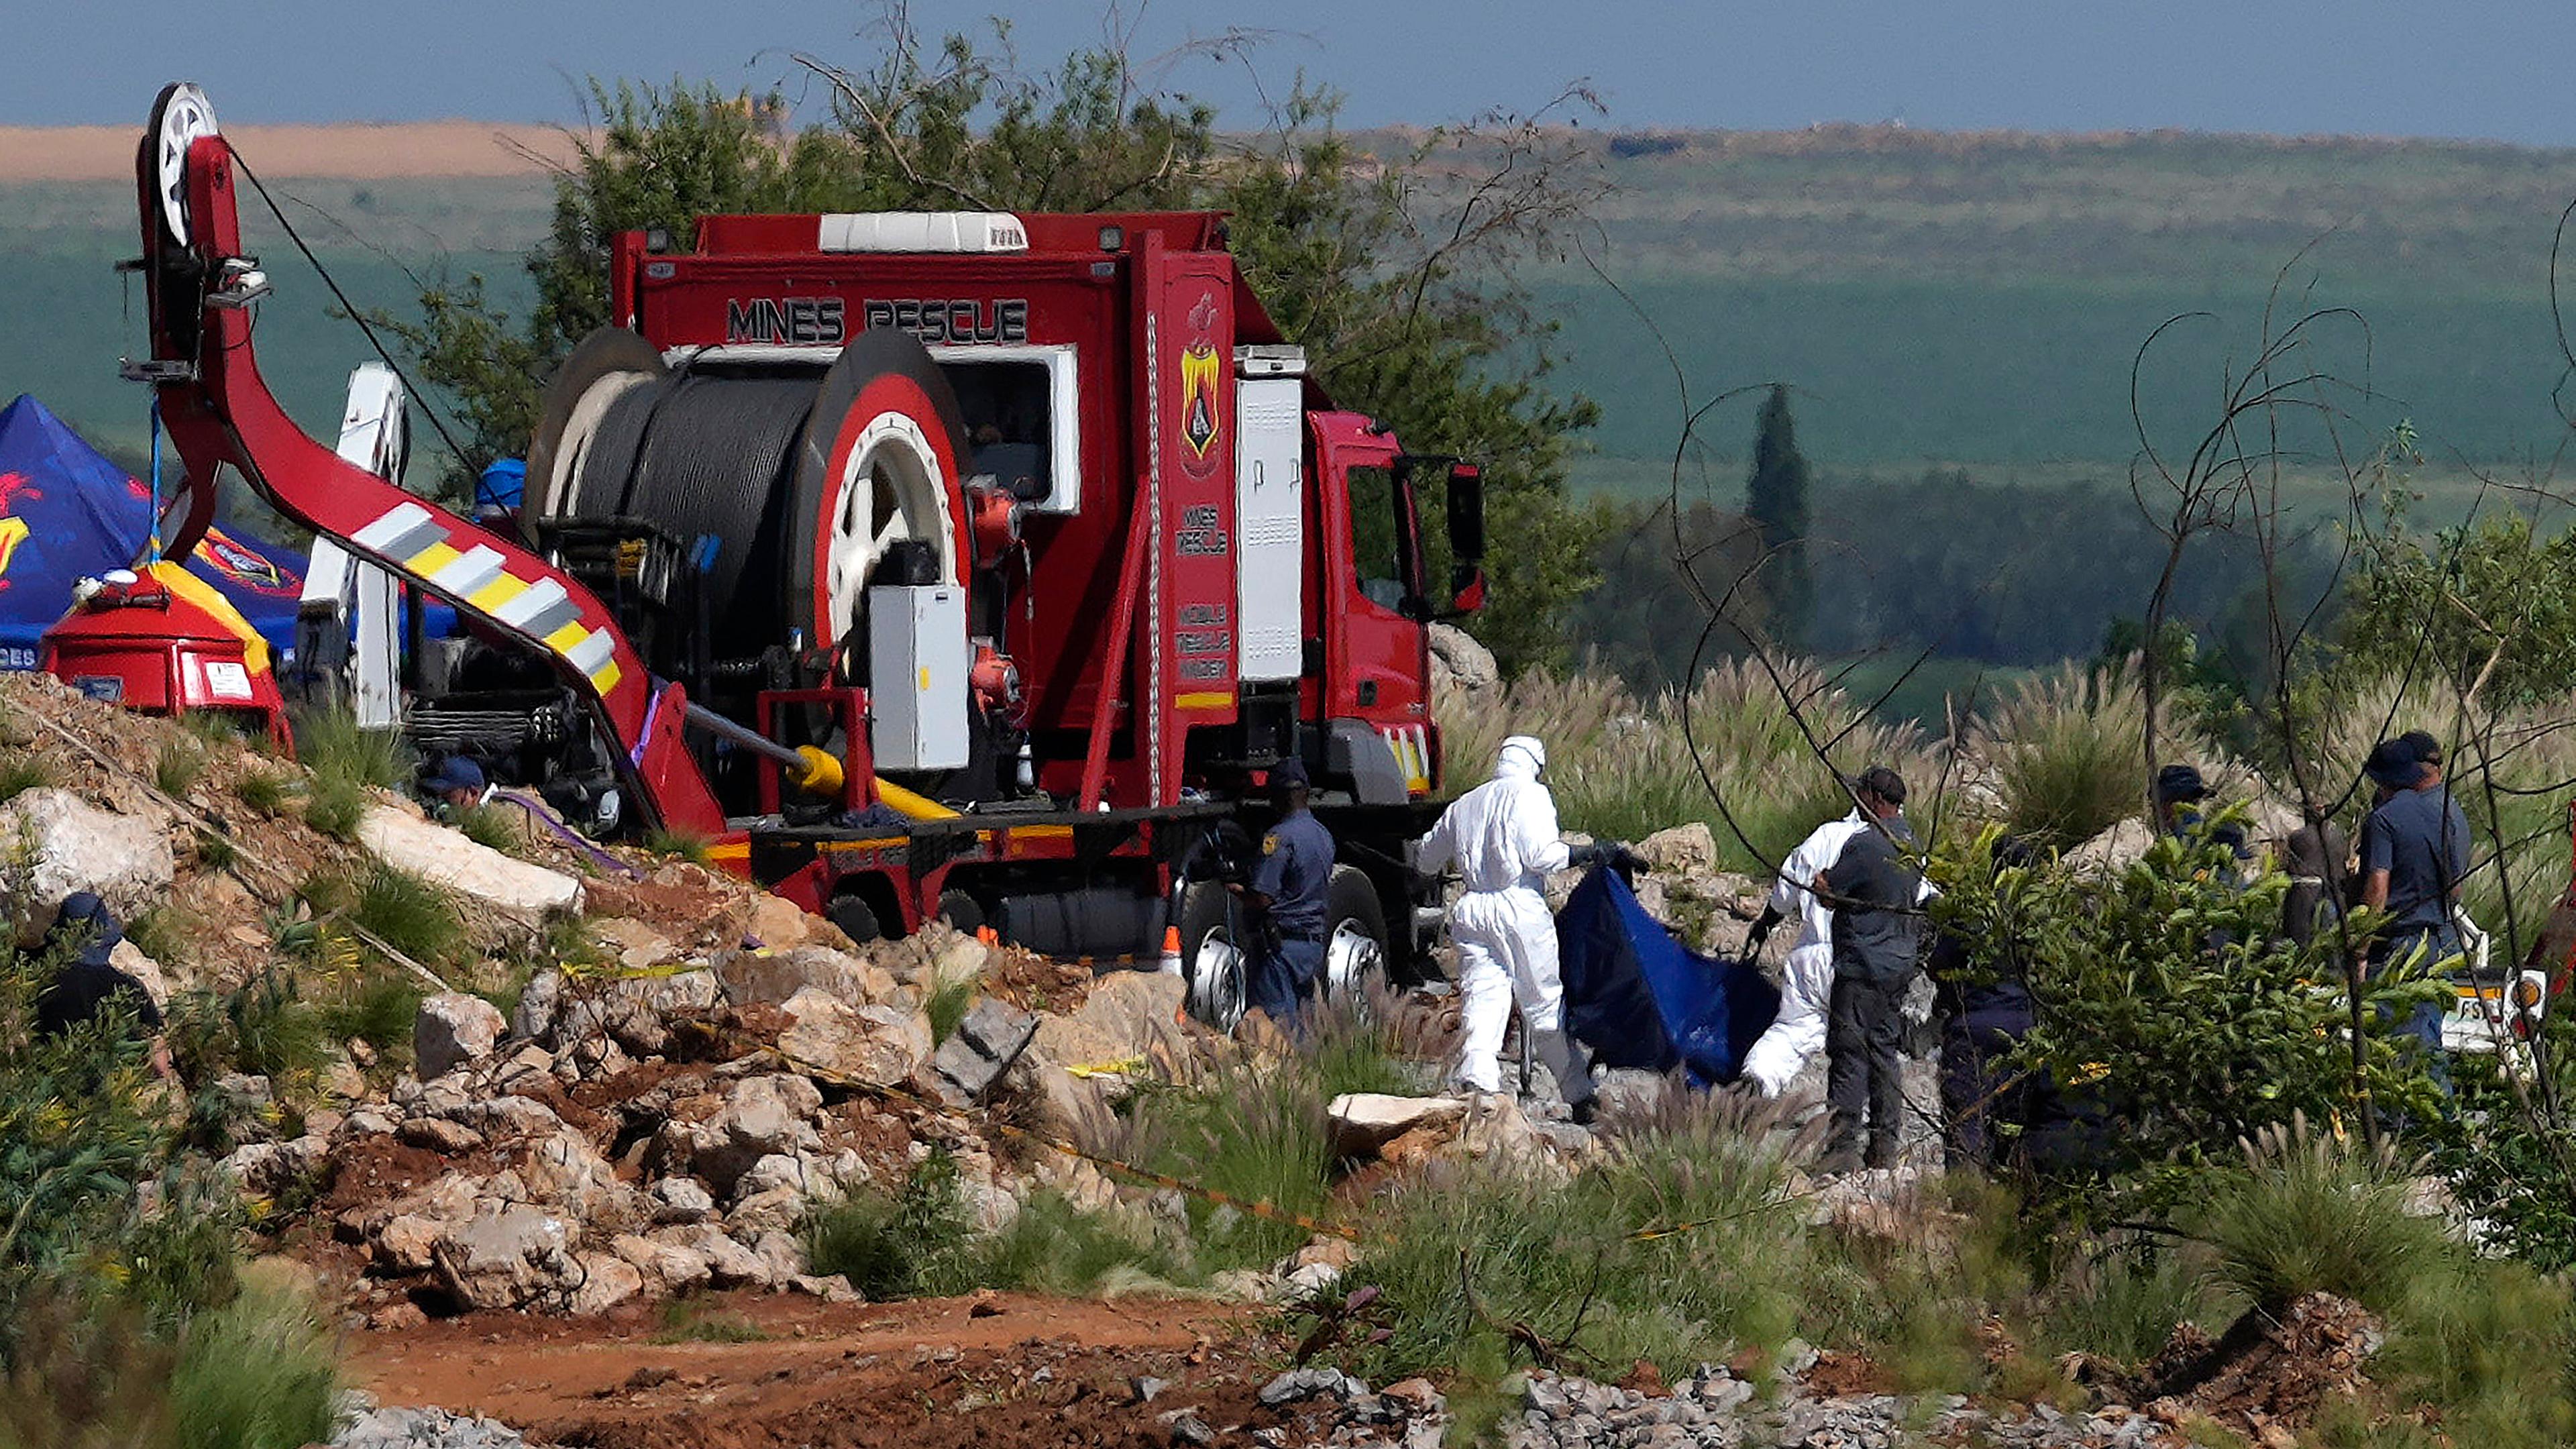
528;327;966;657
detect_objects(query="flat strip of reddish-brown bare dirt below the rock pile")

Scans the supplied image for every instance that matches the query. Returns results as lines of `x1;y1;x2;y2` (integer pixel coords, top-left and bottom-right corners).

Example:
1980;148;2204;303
350;1294;1298;1449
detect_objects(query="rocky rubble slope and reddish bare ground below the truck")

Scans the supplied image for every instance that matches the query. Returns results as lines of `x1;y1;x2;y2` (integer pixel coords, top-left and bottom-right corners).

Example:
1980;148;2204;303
0;676;2357;1449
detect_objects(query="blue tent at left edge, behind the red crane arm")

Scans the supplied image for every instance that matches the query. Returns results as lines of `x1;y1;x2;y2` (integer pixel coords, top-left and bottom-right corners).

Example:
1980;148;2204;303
0;394;304;670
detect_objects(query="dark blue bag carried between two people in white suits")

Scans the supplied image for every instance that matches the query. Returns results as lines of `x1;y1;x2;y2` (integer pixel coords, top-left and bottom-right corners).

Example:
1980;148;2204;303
1556;869;1780;1085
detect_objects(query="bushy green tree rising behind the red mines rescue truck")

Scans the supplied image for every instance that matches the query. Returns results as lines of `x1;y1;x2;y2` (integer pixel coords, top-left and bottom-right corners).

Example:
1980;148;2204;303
386;23;1600;670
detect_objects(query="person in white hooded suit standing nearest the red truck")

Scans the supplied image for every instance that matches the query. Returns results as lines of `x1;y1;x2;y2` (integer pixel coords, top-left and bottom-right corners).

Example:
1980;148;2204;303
1414;735;1592;1122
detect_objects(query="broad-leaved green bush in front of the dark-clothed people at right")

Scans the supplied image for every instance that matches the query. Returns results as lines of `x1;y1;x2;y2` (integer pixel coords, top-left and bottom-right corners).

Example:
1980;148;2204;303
1932;828;2445;1222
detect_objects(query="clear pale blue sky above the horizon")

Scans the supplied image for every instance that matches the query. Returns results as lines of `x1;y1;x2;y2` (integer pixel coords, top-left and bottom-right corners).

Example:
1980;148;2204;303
15;0;2576;144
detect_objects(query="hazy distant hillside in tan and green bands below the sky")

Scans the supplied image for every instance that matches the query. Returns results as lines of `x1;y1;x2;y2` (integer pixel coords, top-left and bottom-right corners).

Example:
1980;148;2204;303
0;121;2576;492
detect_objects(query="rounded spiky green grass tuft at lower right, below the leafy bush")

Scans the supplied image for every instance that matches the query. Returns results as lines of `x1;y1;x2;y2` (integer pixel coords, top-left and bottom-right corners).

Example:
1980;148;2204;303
2192;1116;2453;1315
